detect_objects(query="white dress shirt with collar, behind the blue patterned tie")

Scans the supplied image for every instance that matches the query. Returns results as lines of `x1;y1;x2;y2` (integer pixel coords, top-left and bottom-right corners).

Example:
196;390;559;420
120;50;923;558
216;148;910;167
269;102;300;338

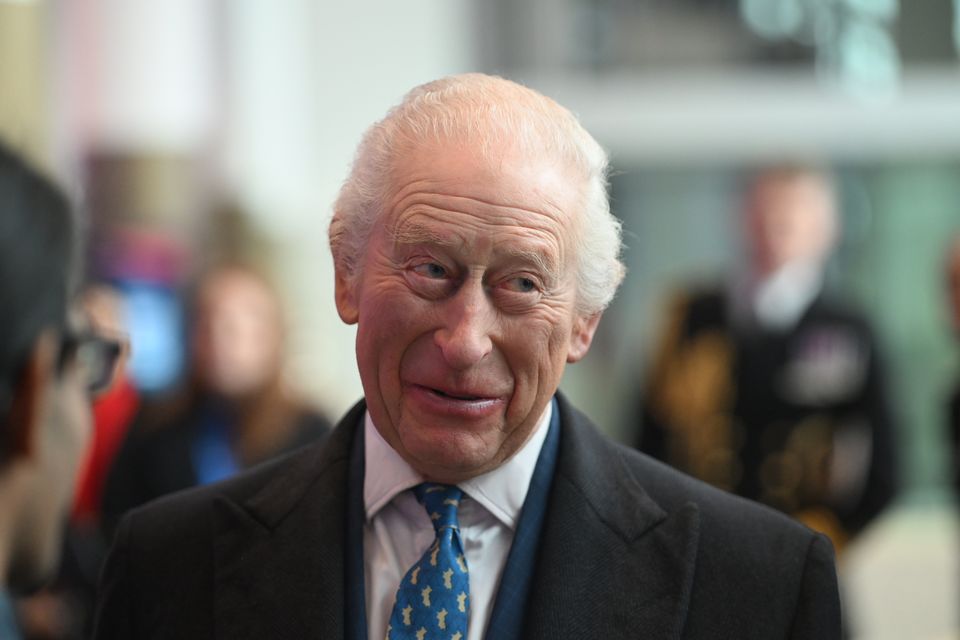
363;402;553;640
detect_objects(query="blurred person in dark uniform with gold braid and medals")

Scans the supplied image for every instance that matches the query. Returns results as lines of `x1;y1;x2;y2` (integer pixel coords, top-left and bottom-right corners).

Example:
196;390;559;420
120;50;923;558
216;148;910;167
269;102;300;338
639;166;896;549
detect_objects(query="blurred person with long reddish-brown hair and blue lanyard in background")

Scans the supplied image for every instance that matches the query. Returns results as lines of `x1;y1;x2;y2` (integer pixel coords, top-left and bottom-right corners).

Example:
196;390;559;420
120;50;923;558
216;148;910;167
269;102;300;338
103;265;330;533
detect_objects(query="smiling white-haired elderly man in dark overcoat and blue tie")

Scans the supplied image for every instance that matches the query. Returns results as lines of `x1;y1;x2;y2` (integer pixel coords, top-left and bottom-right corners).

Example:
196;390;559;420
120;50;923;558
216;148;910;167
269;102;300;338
92;74;839;640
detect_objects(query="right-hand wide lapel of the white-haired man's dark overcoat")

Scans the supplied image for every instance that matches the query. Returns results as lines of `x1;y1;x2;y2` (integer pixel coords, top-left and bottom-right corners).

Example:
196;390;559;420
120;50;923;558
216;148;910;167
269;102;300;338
524;397;699;638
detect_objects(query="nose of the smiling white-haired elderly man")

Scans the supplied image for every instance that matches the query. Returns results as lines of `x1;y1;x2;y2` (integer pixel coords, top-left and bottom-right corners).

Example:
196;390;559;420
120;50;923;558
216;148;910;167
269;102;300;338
434;282;497;371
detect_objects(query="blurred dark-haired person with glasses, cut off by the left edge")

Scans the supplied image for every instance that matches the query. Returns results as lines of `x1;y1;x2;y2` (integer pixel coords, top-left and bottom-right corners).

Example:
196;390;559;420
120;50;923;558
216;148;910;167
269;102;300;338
0;145;121;640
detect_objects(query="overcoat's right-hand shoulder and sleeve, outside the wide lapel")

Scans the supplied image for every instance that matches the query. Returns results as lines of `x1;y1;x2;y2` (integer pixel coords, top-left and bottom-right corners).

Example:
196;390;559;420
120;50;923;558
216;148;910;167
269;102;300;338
615;445;840;639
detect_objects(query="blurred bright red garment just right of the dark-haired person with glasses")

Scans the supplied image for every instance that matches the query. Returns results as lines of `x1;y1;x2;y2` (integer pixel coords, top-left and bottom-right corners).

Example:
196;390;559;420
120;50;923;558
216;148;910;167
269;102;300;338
72;376;140;523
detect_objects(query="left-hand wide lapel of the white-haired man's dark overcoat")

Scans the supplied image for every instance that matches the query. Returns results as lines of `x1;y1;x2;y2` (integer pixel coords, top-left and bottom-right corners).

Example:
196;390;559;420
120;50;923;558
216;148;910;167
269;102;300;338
213;405;363;640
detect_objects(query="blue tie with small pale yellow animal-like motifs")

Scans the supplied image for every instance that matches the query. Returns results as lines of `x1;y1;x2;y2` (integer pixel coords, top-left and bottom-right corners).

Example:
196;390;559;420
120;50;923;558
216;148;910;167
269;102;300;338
387;482;470;640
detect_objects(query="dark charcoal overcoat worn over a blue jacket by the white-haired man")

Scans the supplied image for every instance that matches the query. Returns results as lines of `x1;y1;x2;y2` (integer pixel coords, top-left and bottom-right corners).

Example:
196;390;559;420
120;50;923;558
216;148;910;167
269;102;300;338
95;397;840;640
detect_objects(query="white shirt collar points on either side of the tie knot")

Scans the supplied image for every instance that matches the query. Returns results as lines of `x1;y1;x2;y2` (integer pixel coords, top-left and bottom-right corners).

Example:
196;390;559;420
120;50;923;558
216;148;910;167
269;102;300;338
363;400;553;529
